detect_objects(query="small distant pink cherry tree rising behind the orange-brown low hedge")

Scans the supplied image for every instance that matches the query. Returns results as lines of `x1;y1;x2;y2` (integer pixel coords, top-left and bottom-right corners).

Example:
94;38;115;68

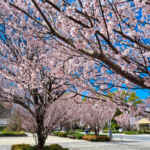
79;100;117;135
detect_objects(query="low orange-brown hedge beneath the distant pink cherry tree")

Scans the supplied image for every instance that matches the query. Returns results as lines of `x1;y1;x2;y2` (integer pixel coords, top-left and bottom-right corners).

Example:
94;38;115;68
82;135;110;142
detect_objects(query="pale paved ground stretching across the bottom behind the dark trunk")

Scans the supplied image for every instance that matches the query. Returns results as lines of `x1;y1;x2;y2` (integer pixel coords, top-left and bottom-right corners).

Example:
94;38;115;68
0;134;150;150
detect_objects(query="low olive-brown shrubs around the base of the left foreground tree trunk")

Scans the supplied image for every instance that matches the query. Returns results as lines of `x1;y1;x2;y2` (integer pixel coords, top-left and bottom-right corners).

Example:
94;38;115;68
11;144;68;150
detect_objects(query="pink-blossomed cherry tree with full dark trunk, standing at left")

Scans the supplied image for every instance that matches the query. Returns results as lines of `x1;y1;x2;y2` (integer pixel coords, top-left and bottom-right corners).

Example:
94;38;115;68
0;24;75;150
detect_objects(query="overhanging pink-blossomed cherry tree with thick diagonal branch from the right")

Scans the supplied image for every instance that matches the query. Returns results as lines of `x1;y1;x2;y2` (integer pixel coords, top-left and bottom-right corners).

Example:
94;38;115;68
1;0;150;89
